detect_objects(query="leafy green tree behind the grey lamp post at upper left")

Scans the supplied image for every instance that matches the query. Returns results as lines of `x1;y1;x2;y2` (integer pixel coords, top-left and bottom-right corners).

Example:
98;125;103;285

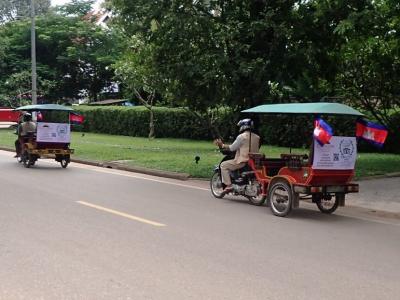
0;7;121;105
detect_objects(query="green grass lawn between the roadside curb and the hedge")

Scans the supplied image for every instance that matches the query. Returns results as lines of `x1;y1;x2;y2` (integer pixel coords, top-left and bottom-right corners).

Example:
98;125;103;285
0;129;400;178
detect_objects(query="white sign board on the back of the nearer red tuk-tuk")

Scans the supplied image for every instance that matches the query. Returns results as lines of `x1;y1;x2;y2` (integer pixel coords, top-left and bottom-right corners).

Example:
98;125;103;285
312;136;357;170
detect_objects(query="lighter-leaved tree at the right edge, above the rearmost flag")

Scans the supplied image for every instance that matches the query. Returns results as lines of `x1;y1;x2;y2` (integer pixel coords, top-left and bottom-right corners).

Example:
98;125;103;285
336;0;400;127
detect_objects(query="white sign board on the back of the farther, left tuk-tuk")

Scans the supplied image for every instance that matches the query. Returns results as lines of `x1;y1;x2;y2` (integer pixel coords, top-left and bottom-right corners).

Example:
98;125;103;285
36;122;71;143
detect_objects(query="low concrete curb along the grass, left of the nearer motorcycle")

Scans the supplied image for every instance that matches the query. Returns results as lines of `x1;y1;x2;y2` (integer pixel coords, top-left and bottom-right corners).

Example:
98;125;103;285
0;146;190;180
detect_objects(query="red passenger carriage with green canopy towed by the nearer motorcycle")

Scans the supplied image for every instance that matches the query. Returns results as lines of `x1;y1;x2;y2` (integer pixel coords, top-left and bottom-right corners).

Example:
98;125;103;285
242;102;363;216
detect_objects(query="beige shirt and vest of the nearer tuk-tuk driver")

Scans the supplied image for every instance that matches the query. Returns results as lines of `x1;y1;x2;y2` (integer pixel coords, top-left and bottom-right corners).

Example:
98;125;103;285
229;131;260;164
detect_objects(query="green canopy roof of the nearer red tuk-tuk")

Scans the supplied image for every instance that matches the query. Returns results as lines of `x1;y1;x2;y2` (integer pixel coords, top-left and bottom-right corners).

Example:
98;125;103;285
242;102;363;116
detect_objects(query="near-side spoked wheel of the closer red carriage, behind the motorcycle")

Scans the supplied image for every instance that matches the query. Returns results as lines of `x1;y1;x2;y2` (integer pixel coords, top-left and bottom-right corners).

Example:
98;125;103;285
268;181;293;217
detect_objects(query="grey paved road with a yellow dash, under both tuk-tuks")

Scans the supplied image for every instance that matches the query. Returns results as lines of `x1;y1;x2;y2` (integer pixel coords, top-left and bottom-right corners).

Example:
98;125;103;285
0;151;400;300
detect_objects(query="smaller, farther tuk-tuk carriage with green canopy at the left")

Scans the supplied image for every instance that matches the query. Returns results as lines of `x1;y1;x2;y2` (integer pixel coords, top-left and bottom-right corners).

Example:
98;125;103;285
15;104;74;168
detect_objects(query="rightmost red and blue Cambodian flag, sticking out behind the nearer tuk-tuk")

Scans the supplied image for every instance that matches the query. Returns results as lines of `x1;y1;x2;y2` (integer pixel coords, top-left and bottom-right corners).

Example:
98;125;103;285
356;119;388;148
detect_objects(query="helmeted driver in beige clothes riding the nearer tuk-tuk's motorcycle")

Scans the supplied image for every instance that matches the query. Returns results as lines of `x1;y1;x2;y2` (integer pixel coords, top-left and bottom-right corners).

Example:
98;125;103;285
215;119;260;194
